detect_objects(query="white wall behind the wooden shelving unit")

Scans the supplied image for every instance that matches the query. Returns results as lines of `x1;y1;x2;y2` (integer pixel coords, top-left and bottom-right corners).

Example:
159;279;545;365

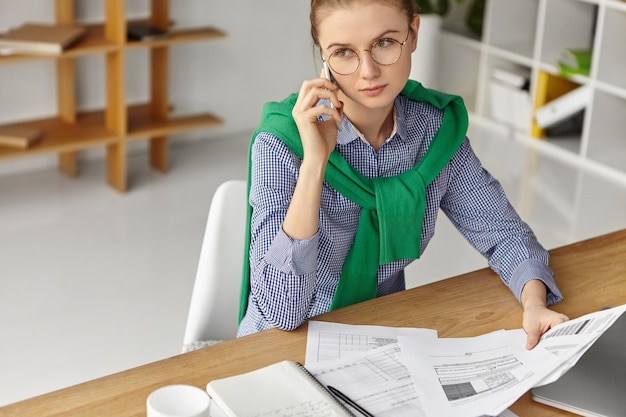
0;0;319;175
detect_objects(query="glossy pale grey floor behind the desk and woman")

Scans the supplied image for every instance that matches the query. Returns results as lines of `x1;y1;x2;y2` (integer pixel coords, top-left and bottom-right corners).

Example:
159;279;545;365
0;124;626;405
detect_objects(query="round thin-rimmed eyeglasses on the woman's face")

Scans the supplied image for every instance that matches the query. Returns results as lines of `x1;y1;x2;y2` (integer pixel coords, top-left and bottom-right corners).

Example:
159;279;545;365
326;30;411;75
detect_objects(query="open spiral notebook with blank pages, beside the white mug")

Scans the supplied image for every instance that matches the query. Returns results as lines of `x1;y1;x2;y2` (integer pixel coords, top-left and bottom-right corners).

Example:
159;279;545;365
206;360;353;417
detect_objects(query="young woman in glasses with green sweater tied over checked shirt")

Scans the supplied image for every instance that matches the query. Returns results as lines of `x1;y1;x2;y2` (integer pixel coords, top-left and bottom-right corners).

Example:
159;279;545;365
239;0;567;348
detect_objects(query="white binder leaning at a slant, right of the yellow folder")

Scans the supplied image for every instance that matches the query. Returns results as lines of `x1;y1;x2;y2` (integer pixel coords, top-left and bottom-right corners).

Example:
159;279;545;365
535;85;591;129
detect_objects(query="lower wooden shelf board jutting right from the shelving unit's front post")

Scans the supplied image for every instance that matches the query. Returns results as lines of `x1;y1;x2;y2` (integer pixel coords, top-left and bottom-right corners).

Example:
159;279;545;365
126;104;223;139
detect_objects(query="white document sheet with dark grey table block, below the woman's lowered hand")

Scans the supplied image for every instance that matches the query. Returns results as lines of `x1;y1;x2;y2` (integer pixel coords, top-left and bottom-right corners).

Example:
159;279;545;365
398;329;560;417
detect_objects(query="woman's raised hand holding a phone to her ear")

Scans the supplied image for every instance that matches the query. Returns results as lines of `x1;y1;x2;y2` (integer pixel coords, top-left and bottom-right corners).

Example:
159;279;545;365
291;76;343;164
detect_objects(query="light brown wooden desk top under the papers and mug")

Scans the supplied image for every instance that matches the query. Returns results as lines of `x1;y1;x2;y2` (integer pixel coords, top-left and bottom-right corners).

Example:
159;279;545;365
0;230;626;417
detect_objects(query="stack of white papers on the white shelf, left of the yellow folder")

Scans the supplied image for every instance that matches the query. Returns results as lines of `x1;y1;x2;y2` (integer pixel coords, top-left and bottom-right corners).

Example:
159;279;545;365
489;68;531;132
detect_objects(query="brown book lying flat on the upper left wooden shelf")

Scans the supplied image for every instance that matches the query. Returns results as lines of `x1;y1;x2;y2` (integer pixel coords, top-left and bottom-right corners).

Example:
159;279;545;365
0;23;85;55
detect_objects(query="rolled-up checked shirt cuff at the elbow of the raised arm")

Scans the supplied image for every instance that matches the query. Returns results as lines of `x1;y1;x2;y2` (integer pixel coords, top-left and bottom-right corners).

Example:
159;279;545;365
265;228;319;275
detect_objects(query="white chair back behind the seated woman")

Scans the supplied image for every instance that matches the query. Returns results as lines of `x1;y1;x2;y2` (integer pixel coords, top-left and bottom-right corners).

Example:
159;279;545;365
183;180;248;352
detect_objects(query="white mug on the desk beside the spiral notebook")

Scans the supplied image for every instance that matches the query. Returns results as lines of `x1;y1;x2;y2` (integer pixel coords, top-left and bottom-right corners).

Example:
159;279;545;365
146;385;210;417
